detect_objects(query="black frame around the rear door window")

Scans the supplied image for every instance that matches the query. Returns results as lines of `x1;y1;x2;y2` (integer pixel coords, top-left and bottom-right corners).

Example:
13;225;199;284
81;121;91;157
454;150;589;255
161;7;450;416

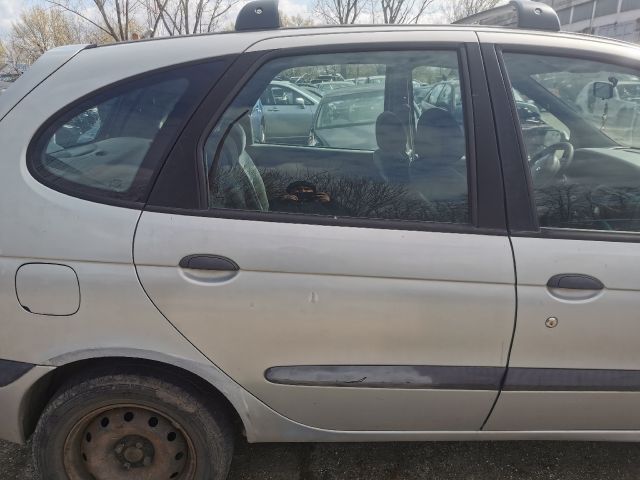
145;41;507;236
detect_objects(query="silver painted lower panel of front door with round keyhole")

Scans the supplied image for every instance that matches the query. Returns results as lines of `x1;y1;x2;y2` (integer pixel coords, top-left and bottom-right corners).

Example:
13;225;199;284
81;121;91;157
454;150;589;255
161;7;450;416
489;238;640;430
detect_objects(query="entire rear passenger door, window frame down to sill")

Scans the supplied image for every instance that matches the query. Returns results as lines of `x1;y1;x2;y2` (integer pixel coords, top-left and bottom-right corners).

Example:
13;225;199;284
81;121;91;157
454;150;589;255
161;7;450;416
135;31;515;431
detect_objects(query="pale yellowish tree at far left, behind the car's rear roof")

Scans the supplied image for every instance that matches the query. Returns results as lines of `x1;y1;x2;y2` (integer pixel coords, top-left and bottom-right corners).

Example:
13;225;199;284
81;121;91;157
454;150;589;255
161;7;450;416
6;7;90;65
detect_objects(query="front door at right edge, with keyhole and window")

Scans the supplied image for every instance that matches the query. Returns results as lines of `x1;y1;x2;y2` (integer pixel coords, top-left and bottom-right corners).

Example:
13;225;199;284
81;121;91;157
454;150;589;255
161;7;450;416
486;35;640;430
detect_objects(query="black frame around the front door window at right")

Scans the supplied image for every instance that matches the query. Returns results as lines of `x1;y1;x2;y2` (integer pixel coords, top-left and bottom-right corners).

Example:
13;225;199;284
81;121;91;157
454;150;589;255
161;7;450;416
492;43;640;243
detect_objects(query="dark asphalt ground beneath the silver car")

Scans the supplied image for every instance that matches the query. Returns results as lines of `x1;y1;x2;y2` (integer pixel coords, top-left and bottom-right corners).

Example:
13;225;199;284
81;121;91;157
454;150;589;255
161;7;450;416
0;442;640;480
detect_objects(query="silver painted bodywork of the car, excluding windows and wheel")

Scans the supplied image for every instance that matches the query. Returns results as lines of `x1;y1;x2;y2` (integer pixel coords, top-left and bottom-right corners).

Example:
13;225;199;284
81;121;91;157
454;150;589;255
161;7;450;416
0;26;640;442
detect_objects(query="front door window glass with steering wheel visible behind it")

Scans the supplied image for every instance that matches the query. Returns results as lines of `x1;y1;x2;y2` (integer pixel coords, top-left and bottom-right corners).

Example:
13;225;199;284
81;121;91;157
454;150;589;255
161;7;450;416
505;53;640;231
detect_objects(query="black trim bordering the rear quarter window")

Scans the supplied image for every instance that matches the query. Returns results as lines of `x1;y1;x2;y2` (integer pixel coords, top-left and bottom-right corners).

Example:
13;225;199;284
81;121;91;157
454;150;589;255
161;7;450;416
26;55;236;210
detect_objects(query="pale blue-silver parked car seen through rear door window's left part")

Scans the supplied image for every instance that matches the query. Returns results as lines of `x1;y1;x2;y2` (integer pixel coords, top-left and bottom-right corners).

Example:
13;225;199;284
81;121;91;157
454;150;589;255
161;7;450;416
252;81;320;144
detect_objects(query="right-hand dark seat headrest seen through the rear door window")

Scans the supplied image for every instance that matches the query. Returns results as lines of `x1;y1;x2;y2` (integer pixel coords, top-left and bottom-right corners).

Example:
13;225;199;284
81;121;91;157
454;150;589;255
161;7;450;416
415;107;466;164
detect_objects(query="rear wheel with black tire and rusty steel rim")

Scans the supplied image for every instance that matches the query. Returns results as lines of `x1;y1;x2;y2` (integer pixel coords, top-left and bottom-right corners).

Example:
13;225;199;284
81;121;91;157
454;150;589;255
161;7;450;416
33;368;234;480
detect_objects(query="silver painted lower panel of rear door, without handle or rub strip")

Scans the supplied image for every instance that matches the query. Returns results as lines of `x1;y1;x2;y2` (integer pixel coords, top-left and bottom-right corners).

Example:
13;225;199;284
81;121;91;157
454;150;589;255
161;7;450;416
135;212;515;430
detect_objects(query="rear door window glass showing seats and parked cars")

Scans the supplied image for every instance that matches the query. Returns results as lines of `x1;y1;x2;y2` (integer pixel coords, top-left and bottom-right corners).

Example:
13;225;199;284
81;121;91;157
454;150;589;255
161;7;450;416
204;51;469;223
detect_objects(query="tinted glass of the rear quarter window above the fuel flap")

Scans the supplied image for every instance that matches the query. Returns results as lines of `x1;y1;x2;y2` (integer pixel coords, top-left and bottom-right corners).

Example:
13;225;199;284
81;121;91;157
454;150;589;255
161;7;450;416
39;79;188;193
